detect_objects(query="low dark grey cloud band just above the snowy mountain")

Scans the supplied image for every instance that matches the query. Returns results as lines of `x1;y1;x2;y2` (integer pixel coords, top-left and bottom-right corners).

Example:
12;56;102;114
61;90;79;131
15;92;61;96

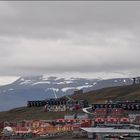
0;57;140;76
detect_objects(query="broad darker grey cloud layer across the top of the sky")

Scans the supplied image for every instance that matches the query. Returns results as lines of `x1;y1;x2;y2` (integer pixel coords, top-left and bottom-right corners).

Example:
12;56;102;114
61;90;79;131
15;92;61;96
0;1;140;38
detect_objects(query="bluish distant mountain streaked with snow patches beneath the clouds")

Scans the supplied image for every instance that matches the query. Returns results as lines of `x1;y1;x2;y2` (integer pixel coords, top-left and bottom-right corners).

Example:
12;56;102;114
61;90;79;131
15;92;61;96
0;76;132;111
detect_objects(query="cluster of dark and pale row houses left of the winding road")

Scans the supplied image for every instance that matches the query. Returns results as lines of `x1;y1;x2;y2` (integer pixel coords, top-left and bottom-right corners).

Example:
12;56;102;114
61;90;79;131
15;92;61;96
27;98;88;112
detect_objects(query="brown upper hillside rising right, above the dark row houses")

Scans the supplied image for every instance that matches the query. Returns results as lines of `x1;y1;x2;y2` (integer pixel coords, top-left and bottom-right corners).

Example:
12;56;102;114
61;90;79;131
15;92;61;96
73;85;140;103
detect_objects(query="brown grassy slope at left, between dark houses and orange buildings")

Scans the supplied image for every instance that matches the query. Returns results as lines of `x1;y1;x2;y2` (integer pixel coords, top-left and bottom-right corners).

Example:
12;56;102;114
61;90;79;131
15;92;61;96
0;107;82;121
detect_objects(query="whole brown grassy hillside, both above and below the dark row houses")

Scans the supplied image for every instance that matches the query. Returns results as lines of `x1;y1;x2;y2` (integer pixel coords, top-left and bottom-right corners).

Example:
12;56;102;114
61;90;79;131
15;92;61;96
0;85;140;121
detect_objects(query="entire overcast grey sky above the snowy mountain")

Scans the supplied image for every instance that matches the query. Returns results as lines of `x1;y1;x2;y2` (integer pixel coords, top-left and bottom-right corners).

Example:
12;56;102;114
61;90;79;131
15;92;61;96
0;1;140;84
